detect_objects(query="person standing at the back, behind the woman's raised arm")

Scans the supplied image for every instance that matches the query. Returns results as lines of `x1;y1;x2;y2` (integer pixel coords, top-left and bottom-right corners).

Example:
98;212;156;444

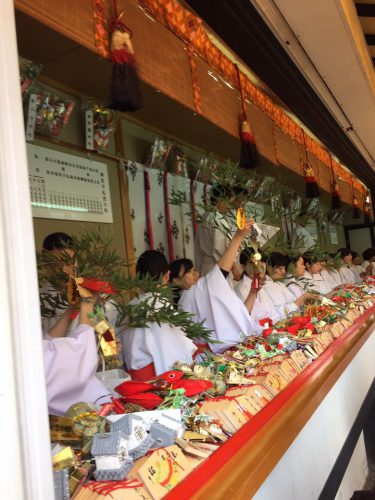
194;188;233;276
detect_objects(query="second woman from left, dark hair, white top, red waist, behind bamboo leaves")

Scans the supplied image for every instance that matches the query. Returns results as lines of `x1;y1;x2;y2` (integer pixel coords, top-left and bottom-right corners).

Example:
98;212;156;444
119;250;197;380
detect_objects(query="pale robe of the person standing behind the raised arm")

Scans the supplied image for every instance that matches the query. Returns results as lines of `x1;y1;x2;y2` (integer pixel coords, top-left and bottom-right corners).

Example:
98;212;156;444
194;212;229;276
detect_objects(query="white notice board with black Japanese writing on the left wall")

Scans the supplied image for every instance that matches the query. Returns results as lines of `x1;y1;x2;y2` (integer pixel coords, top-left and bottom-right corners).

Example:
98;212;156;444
27;144;113;223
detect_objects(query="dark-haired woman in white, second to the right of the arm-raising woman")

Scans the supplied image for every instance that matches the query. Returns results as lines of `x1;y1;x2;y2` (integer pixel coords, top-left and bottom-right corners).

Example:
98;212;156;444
261;252;316;320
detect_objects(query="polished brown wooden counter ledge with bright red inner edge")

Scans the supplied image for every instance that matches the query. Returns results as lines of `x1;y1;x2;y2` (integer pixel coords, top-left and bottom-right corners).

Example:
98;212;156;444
166;306;375;500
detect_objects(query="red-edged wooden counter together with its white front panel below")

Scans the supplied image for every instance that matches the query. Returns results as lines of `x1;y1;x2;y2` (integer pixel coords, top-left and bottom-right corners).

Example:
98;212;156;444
166;306;375;500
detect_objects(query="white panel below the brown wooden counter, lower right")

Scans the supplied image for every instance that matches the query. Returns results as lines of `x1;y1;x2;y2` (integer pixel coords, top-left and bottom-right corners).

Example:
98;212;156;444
253;326;375;500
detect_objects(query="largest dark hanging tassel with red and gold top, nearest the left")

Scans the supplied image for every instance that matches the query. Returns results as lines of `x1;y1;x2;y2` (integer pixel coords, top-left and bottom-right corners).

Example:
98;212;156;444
109;0;142;111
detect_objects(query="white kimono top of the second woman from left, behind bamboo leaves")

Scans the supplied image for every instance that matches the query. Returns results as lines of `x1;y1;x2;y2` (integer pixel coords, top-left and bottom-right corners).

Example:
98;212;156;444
119;294;197;375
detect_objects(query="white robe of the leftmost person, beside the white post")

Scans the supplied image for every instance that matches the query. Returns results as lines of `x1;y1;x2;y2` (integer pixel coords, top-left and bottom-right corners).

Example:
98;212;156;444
43;325;110;415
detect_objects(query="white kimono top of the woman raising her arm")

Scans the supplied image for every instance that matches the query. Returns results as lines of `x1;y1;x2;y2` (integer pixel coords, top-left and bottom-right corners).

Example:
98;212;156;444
178;265;255;352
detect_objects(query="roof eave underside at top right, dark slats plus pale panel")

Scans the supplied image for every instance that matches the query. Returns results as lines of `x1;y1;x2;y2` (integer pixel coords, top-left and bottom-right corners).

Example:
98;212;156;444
185;0;375;189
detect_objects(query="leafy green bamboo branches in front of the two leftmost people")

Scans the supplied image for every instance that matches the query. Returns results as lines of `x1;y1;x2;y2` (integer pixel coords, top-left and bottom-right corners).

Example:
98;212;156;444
37;228;211;340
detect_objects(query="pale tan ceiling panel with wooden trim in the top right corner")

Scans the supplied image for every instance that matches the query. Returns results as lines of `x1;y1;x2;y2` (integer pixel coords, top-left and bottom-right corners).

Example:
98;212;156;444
252;0;375;169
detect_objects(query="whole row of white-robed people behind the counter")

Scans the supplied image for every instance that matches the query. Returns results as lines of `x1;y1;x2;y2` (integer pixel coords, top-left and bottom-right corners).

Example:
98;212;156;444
38;201;375;414
